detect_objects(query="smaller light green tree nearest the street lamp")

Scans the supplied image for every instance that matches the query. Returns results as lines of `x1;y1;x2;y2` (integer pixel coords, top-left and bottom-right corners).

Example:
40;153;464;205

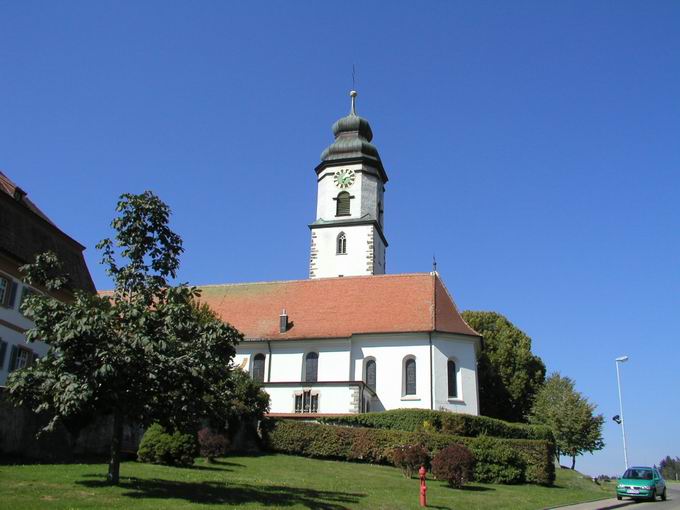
529;372;604;469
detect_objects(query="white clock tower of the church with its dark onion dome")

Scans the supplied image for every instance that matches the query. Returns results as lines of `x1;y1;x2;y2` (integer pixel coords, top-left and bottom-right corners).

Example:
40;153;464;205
309;90;387;278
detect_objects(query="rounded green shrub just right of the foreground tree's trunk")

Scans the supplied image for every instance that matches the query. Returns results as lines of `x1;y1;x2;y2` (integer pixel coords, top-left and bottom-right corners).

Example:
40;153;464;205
137;423;196;466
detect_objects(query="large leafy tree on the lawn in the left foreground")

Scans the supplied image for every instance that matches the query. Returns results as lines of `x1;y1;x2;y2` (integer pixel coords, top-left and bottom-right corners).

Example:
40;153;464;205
8;191;241;484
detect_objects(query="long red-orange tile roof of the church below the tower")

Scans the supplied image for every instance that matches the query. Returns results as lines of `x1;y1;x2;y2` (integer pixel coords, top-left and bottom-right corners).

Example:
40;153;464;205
199;273;480;340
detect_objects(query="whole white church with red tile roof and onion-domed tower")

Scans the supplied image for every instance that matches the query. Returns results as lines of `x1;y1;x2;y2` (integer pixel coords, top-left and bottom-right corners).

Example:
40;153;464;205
201;91;482;418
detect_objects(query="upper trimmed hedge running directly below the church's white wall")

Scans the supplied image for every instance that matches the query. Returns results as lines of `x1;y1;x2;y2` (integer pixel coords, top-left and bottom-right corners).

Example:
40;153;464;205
318;409;554;442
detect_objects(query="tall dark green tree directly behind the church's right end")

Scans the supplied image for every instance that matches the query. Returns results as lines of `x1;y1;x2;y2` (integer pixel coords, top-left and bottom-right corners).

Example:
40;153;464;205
462;310;545;421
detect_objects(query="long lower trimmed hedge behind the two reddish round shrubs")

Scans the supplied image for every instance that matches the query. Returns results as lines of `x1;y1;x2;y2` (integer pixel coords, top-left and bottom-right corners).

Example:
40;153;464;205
266;420;555;485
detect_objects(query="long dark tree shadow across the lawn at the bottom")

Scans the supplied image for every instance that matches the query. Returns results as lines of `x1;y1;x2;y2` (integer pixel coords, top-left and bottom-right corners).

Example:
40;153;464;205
76;478;365;510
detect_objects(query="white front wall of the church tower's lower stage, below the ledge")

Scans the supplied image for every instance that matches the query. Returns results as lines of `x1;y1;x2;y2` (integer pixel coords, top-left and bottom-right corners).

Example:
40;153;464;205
312;225;375;278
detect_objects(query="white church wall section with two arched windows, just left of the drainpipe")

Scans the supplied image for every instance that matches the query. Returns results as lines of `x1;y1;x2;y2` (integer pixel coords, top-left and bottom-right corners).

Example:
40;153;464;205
352;333;430;411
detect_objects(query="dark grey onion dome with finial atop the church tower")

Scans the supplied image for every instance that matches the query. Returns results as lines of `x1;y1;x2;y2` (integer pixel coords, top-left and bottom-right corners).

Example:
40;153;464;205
321;90;380;162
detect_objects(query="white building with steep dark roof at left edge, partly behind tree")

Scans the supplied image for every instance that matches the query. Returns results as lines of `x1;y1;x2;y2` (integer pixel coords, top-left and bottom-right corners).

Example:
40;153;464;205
0;172;95;385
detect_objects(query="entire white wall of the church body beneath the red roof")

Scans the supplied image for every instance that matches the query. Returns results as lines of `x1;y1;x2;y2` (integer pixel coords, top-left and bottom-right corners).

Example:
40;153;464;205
234;333;479;414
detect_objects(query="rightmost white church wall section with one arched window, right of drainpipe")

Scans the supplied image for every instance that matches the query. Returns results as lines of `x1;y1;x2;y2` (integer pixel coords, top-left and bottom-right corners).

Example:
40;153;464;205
432;333;479;415
